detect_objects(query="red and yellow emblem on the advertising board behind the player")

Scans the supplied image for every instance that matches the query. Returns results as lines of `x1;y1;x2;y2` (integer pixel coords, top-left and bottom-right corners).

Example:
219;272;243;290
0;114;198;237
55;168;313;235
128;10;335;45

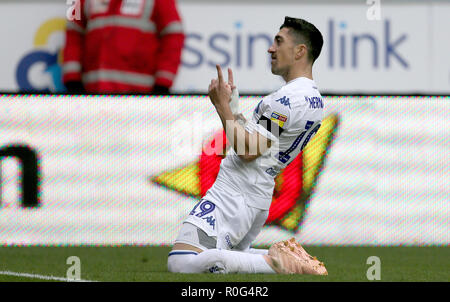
151;114;338;232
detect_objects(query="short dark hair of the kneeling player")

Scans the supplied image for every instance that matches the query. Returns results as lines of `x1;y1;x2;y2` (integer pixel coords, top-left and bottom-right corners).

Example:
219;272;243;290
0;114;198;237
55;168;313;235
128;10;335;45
280;17;323;63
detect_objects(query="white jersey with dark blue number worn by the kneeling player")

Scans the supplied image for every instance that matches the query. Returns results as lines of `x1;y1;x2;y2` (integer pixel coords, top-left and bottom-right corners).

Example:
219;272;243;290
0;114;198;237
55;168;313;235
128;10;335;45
206;77;323;210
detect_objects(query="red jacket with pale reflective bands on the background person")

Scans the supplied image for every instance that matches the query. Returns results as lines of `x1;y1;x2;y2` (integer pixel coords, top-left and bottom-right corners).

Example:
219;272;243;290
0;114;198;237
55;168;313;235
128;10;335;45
63;0;184;93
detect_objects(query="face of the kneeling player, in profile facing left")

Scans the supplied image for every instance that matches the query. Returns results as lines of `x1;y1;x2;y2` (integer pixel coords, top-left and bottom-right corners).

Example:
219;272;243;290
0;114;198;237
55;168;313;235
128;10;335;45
268;27;295;76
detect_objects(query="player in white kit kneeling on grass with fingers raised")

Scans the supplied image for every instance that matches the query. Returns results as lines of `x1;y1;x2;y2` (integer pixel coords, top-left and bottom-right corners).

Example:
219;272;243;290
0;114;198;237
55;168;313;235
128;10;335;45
168;17;327;275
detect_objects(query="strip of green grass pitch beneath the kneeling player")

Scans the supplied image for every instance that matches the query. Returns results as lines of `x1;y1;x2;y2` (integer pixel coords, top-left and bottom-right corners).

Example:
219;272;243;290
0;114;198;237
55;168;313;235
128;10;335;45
0;246;450;282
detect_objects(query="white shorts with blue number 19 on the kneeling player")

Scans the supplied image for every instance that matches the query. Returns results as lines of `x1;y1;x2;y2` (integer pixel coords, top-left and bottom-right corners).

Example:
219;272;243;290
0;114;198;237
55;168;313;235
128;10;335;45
175;186;269;251
